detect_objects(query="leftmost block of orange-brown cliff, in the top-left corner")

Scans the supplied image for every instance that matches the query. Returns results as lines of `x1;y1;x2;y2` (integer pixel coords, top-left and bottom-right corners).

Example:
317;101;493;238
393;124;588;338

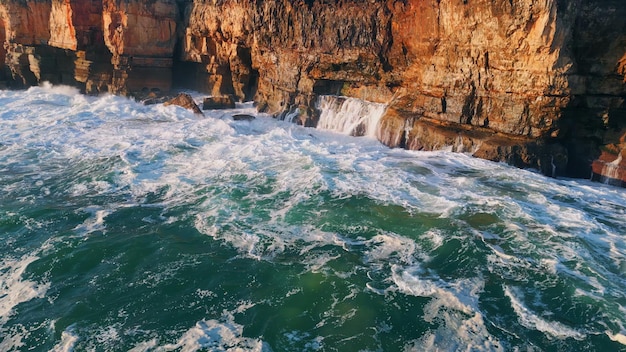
0;0;112;93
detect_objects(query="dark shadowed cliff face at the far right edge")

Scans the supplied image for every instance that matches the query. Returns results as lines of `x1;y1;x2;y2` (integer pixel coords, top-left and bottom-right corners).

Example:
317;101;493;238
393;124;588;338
557;0;626;178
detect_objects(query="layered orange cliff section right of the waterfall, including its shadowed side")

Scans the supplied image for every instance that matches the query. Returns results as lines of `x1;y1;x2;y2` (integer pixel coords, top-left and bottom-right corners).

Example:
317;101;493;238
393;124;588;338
379;0;626;177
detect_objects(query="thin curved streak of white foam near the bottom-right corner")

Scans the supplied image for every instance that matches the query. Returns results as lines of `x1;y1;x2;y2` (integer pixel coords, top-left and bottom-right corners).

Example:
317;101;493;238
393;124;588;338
504;286;586;340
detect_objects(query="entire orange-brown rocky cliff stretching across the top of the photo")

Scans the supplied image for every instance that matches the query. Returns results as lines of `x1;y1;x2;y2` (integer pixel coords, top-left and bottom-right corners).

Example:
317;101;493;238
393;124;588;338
0;0;626;184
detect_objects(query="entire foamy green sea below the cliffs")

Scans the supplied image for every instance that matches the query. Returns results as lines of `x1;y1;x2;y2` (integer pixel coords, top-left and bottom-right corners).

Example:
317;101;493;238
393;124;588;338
0;86;626;352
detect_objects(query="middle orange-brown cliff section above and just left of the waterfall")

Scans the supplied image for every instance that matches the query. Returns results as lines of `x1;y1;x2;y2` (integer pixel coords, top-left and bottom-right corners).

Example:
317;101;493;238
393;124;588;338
173;0;392;125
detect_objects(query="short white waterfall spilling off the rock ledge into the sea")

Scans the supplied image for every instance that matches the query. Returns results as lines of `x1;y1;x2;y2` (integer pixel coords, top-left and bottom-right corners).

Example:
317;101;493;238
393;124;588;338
317;95;387;137
